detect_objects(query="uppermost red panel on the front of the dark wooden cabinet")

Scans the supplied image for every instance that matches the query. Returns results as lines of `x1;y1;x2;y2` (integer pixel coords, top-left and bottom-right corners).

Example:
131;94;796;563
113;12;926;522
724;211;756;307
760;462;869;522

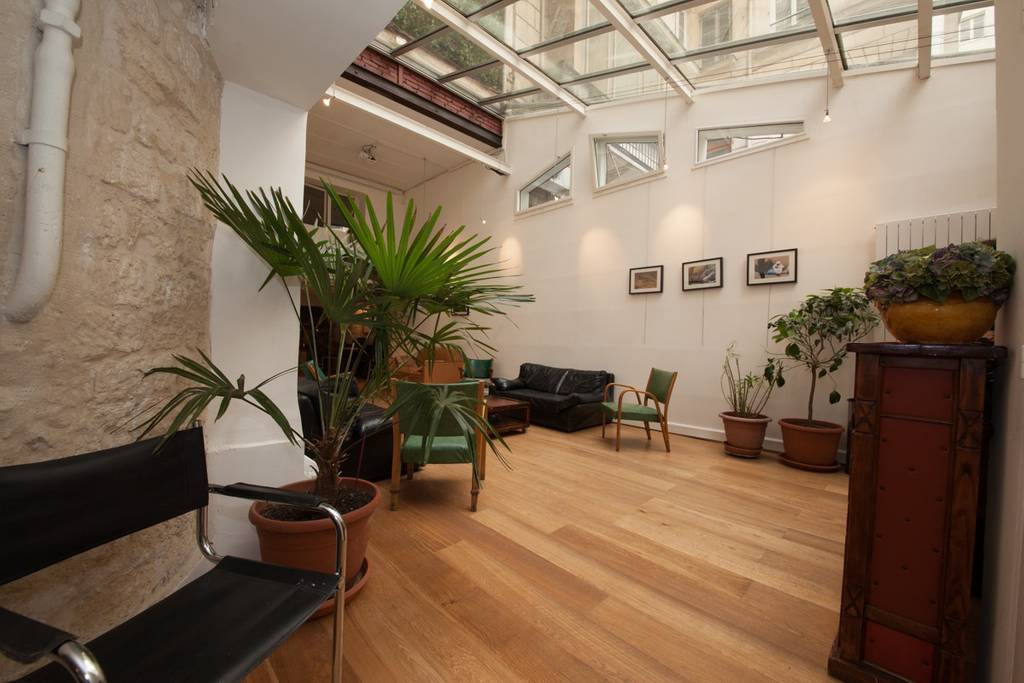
881;367;955;422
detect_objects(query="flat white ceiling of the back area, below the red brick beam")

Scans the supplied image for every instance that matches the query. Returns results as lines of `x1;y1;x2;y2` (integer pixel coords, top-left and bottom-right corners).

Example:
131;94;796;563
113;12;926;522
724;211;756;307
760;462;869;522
306;80;493;191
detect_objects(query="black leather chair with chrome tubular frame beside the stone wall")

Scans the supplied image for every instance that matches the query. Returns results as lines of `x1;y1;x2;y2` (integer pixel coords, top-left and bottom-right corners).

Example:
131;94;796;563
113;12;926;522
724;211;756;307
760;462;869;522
0;428;347;683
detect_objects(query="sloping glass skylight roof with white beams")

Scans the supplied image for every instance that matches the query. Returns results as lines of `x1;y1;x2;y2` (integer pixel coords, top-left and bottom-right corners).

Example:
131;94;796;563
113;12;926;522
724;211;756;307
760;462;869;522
374;0;995;116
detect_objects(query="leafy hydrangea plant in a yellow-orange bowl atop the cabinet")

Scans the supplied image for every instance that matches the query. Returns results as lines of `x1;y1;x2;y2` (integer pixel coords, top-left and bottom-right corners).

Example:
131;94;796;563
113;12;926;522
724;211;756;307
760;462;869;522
864;242;1016;344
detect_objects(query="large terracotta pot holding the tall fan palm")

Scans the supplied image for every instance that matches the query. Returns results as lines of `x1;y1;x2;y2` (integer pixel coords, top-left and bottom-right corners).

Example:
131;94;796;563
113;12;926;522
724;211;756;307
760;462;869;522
249;477;381;618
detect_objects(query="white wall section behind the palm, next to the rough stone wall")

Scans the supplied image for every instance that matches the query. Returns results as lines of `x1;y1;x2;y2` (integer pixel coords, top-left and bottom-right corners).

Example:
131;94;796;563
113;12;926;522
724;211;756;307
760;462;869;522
206;83;306;557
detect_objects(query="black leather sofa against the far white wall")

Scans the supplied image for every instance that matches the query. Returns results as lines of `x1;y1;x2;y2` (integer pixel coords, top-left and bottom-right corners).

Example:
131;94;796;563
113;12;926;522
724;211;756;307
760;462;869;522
492;362;615;432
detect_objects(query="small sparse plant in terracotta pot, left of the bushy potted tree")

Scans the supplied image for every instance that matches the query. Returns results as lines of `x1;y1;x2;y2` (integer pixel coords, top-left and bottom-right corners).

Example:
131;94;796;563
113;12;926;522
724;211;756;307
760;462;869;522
719;342;785;458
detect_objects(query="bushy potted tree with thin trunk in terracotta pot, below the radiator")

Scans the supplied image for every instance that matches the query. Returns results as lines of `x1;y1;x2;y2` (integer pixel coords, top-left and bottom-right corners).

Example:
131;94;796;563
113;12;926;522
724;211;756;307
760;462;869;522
768;287;878;472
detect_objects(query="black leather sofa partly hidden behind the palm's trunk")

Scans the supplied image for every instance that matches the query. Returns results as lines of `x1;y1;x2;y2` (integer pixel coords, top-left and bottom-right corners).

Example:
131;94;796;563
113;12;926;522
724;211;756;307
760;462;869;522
299;377;391;481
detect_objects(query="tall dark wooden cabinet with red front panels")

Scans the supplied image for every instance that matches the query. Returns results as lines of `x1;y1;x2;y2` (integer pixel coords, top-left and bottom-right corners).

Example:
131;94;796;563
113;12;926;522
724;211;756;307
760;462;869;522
828;344;1006;683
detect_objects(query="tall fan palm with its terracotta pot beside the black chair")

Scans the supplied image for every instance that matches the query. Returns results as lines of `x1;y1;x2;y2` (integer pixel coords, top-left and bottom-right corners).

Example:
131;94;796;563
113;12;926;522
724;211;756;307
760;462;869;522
138;171;532;613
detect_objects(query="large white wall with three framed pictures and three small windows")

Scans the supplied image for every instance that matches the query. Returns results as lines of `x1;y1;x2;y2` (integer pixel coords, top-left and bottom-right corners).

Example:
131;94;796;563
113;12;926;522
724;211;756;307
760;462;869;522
419;60;995;450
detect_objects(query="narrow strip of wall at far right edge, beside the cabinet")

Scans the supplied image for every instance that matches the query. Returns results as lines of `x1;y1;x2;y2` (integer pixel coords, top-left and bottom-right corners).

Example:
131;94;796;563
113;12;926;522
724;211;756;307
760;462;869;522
985;0;1024;682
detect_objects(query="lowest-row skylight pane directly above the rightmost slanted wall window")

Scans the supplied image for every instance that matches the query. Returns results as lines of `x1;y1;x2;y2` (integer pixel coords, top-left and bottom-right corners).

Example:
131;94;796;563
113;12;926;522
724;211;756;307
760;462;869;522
677;37;825;88
